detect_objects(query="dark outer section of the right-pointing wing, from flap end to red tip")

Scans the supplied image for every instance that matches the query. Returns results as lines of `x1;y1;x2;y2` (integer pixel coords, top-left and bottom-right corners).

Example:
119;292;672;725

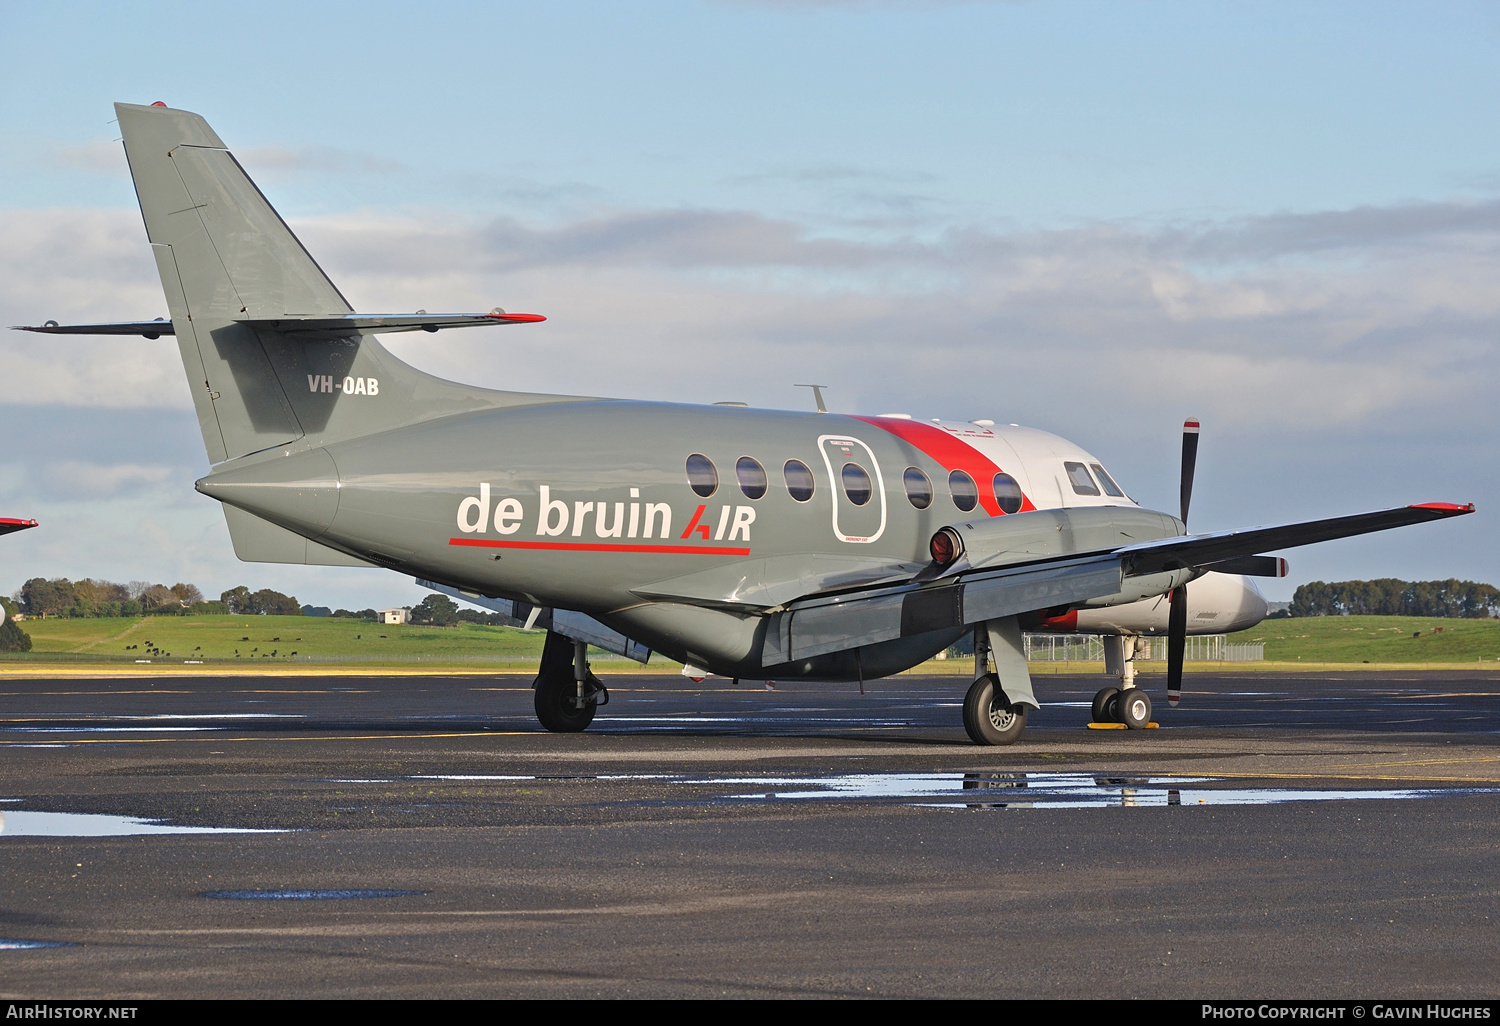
1115;503;1475;576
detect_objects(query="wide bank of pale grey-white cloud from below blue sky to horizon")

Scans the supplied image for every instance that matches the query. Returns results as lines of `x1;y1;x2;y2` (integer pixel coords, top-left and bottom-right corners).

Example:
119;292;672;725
0;192;1500;606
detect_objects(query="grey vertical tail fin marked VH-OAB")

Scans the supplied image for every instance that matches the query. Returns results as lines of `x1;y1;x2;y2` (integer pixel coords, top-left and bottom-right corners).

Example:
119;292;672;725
114;104;560;464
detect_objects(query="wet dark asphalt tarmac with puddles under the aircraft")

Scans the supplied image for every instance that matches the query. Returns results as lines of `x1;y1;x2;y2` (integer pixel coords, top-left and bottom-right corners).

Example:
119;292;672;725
0;668;1500;999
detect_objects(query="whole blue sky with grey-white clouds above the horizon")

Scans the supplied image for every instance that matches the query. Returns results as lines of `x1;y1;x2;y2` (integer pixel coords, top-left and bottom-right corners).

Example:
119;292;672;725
0;0;1500;608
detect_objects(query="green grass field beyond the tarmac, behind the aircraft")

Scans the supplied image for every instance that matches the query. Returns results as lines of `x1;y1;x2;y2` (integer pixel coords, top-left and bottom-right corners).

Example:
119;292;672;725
0;617;1500;674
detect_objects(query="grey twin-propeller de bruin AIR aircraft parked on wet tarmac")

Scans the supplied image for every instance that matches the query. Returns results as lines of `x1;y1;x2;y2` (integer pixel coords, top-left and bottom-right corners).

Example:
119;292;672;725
27;104;1473;744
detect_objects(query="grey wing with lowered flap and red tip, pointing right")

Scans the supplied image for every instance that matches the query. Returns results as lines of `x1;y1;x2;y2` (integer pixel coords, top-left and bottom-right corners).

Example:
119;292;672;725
762;503;1475;666
